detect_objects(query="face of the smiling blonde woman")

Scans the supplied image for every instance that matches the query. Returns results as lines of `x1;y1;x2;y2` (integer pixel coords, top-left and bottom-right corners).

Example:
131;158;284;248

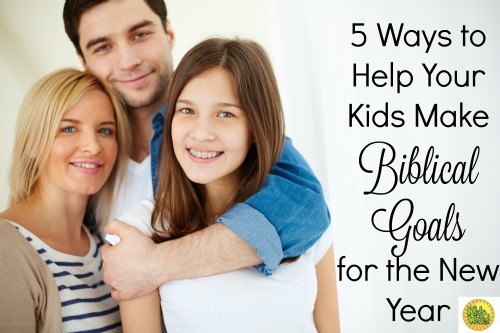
40;90;118;195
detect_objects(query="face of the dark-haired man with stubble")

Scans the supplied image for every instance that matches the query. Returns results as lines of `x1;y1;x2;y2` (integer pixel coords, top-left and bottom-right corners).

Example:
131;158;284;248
78;0;174;109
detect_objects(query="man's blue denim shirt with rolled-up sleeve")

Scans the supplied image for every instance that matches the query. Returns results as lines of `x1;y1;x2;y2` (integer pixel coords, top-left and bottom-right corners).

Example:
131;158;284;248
150;105;330;275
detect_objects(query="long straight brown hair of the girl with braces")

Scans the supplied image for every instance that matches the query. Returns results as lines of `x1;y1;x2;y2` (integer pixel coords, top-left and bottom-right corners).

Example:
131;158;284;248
151;38;284;242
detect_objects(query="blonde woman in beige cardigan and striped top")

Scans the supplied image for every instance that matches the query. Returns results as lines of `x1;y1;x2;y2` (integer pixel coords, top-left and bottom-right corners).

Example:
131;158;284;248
0;69;129;333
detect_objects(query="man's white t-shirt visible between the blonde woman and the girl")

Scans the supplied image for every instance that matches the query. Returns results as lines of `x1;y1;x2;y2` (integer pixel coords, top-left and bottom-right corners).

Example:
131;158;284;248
109;155;153;221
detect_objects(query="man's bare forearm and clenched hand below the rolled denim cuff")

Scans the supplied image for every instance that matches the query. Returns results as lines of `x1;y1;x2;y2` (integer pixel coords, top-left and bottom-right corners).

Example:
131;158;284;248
101;220;262;301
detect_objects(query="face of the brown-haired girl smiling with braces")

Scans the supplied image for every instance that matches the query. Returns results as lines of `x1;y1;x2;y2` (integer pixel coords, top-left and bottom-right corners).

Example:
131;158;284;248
172;67;252;191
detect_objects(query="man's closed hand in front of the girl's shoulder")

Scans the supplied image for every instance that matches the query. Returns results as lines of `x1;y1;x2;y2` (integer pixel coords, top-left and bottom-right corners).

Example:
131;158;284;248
101;220;157;301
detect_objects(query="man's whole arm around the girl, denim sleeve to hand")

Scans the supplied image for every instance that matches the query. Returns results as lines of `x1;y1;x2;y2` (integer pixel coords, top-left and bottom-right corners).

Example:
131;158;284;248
103;139;330;300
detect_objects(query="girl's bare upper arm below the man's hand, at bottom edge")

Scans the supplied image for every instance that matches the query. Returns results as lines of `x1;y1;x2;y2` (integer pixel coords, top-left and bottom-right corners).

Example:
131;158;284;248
120;289;162;333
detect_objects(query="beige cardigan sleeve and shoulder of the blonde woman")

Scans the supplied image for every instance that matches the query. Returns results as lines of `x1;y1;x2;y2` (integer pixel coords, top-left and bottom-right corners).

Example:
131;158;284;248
0;219;62;333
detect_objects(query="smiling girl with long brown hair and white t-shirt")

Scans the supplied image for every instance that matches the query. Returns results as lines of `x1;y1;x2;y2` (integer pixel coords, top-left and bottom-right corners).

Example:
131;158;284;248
118;39;339;333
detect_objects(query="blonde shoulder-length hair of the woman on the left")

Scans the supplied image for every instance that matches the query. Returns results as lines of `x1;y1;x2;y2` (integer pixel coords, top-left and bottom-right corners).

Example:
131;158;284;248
9;68;130;227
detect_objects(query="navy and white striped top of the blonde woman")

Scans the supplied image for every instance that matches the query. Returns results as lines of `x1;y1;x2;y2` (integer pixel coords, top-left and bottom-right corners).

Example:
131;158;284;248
11;222;122;332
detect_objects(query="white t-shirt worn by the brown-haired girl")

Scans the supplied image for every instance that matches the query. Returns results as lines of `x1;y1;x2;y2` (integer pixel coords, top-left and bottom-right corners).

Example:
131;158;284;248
120;200;333;333
